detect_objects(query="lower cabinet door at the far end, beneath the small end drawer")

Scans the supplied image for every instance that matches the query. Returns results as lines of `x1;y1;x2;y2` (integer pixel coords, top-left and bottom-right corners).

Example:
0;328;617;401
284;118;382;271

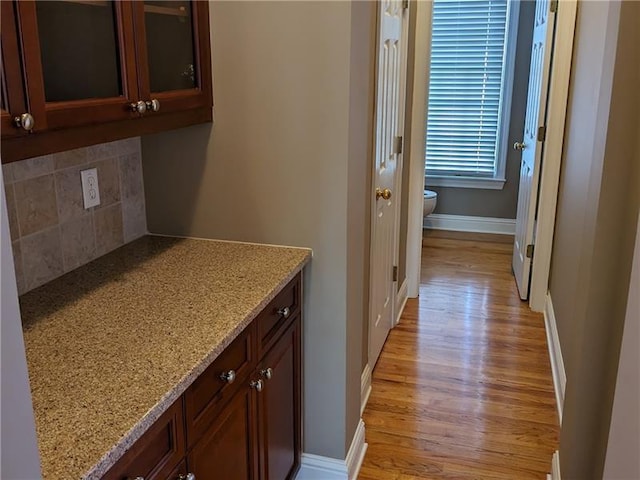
257;315;301;480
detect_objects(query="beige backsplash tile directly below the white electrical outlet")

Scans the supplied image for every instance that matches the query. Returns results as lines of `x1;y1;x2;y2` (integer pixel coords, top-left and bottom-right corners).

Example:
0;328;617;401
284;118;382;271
60;213;96;272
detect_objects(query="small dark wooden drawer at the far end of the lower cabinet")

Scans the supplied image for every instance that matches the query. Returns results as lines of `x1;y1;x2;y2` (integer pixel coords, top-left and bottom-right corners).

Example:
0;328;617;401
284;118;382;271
254;274;301;357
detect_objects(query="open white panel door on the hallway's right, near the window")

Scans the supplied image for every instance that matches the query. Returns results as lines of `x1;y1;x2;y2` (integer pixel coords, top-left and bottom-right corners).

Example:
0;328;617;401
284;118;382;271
513;0;555;300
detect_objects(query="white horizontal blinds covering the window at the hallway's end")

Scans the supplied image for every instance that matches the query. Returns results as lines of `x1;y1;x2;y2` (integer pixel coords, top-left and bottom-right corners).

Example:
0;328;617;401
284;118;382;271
425;0;509;177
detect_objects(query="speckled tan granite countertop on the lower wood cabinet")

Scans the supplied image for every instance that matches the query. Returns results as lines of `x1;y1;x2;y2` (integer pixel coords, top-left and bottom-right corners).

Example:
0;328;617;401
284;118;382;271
20;236;311;480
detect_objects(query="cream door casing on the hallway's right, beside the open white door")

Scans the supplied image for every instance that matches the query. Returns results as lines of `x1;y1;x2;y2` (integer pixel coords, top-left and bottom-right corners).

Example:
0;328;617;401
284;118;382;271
529;0;577;312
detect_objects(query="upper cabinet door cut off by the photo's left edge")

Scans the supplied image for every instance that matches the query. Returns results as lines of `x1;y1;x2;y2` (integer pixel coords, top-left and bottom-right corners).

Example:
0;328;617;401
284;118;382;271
0;1;28;138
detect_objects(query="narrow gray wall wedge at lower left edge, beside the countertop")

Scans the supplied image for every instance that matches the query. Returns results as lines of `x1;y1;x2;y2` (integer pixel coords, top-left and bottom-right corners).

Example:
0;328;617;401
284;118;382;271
0;174;41;480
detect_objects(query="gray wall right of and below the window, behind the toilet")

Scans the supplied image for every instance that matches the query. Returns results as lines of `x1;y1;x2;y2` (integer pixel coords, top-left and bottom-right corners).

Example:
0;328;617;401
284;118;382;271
427;1;535;218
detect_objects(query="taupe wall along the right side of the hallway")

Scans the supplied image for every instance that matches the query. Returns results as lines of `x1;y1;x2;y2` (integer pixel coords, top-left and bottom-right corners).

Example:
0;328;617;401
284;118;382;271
550;2;640;479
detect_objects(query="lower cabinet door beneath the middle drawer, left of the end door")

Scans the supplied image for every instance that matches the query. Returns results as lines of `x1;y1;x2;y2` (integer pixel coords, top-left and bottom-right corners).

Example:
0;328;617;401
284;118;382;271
187;384;257;480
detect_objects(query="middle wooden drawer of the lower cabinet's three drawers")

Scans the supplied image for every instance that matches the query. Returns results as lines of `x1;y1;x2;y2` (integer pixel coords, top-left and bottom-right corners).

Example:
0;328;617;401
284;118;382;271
185;324;257;445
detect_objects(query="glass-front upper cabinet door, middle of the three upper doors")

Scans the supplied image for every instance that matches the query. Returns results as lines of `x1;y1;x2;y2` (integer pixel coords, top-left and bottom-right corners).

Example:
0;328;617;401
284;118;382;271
14;0;139;132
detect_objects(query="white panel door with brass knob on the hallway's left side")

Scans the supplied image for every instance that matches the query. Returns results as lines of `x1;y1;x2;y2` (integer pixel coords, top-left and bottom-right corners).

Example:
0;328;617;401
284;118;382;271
369;0;404;368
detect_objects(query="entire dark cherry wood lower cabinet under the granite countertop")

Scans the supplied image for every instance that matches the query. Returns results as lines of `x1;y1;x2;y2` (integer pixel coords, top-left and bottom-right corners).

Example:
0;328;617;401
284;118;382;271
103;275;302;480
